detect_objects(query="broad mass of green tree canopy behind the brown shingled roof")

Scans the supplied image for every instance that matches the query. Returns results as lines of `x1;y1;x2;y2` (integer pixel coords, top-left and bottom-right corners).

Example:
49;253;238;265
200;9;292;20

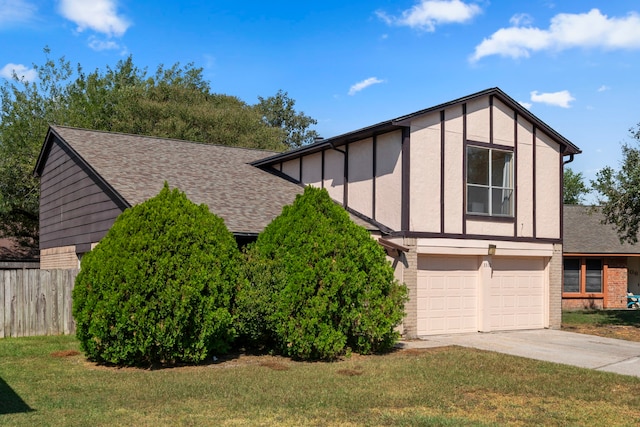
0;48;316;251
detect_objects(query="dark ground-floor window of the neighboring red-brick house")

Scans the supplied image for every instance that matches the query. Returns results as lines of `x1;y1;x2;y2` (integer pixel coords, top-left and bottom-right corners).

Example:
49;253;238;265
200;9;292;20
563;258;603;294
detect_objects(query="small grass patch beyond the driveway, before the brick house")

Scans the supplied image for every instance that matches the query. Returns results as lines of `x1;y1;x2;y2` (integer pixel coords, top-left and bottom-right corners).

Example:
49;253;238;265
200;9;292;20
562;310;640;342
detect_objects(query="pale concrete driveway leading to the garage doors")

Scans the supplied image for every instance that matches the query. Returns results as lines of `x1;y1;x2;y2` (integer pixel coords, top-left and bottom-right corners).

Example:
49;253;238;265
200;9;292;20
399;329;640;377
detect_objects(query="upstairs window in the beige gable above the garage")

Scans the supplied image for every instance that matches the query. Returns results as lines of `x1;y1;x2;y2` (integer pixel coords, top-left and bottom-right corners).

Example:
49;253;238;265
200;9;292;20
467;146;513;216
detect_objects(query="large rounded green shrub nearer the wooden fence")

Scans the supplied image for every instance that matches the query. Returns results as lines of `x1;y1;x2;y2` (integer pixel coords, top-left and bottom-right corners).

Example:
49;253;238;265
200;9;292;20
73;183;239;365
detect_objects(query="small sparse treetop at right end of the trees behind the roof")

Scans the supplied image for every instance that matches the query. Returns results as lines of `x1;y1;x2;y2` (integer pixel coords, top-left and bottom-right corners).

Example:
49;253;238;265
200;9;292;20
256;90;319;148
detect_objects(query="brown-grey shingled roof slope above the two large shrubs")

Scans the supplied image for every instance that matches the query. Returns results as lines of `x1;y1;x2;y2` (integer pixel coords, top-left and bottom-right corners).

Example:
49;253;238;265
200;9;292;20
34;126;375;235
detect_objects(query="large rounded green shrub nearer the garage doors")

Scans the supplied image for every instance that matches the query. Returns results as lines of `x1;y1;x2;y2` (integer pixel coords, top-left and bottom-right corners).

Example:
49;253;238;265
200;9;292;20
235;187;406;359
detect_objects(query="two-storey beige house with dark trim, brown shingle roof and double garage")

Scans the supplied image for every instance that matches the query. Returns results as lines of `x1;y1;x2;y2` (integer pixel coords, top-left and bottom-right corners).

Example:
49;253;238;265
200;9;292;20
36;88;580;337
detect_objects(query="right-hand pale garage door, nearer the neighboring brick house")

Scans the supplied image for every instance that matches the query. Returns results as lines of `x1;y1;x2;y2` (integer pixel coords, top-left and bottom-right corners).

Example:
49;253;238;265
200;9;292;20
488;257;545;331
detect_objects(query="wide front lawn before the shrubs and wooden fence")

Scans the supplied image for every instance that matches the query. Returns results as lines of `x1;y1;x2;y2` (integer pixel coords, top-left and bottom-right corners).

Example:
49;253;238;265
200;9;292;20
0;336;640;426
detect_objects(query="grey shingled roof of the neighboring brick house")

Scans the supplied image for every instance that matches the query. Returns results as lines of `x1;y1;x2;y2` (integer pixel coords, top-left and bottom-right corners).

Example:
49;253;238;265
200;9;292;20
562;205;640;255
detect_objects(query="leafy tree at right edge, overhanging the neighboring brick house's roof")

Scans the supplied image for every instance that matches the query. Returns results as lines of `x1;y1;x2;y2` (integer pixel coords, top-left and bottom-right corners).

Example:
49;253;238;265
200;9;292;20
591;132;640;244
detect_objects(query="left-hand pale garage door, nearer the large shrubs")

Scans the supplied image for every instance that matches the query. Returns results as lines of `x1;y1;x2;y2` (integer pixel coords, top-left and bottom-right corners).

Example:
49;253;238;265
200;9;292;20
416;256;479;335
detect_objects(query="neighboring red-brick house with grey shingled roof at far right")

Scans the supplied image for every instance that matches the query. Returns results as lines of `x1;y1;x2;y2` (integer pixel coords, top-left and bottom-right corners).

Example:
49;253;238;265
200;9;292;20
562;205;640;310
